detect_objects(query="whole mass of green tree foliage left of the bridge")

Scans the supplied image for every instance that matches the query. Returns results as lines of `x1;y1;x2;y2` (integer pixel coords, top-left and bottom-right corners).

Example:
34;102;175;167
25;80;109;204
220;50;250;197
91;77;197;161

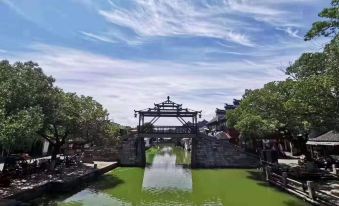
0;61;120;161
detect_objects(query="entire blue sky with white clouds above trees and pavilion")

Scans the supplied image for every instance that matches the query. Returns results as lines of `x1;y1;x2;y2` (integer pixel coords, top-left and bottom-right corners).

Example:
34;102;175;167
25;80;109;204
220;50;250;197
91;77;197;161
0;0;330;126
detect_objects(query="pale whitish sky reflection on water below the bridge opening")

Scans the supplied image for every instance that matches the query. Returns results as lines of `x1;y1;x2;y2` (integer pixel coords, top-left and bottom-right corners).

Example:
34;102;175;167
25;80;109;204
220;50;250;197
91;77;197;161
142;146;192;191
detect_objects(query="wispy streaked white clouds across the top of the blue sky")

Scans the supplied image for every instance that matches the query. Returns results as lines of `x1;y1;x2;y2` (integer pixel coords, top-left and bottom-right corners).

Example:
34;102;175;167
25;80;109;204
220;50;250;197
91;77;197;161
81;0;322;47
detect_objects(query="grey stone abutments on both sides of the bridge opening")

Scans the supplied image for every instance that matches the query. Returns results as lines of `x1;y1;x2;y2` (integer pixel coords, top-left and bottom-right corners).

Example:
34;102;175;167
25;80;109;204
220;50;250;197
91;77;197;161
119;134;259;168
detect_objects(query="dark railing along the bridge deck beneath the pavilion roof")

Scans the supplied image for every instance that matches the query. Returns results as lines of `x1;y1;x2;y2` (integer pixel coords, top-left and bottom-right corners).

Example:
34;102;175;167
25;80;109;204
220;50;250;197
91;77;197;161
141;126;197;134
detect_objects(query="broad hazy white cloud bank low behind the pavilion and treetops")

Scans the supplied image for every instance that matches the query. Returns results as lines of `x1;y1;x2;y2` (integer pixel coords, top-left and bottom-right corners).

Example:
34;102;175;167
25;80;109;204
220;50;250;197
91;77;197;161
5;44;290;125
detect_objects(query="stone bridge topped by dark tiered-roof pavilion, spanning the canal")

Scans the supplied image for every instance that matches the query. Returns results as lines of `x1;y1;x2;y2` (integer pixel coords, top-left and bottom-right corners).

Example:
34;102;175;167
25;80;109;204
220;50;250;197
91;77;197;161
119;97;259;168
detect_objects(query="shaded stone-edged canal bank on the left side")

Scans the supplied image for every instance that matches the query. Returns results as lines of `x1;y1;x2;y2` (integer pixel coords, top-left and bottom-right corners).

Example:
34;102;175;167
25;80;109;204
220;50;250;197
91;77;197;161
0;162;118;206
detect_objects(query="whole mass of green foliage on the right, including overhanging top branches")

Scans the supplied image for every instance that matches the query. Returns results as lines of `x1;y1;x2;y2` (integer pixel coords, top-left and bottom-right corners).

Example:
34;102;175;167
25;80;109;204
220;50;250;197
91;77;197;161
227;0;339;146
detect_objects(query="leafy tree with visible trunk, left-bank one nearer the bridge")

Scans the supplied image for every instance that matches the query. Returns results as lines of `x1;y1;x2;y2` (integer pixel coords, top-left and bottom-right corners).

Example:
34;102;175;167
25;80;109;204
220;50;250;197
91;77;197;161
39;89;117;166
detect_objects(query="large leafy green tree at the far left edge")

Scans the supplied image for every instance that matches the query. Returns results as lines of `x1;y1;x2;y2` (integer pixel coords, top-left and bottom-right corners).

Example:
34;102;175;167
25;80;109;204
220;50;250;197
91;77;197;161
0;61;54;153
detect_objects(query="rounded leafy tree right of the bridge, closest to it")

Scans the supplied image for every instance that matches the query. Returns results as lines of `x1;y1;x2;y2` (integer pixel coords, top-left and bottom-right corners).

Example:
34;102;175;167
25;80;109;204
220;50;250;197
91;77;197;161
227;80;316;152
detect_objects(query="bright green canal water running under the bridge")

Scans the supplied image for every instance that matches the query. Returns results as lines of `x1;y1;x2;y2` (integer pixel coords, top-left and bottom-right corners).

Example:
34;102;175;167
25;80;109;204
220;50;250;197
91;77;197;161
35;146;306;206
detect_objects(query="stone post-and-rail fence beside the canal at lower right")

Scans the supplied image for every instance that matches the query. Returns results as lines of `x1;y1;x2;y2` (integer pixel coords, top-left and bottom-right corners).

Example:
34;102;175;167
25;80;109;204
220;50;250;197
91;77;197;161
264;166;339;206
